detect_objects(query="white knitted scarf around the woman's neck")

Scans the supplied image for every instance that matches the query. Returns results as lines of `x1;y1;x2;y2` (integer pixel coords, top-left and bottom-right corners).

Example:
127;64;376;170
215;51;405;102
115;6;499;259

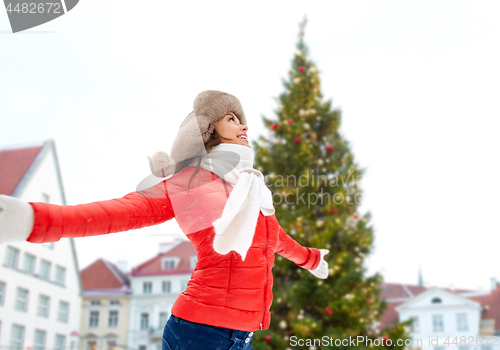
190;143;274;260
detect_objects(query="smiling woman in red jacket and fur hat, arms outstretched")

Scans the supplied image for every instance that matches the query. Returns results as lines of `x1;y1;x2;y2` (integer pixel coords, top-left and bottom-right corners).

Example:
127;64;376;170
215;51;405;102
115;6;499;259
0;90;328;350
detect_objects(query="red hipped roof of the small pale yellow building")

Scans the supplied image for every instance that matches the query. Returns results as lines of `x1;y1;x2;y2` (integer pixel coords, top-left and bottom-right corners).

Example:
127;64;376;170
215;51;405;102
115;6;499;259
80;259;129;290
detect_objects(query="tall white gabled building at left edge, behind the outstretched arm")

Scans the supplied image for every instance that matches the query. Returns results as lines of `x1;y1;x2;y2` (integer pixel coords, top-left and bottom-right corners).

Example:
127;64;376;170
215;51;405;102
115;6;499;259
0;140;81;350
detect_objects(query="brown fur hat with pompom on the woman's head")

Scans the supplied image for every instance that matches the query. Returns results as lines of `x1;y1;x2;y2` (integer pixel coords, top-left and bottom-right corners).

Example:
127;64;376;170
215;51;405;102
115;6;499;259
149;90;247;177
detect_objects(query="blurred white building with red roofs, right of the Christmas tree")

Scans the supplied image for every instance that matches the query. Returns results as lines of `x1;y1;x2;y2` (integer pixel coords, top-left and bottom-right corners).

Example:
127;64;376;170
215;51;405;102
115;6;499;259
379;279;500;350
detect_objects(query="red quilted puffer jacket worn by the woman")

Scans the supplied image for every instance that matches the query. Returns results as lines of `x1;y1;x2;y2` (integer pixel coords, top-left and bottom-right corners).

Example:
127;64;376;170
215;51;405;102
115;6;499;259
28;167;321;331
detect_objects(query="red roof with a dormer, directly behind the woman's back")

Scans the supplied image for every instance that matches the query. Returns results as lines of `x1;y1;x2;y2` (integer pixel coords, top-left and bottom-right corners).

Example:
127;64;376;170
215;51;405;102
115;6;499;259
131;241;196;277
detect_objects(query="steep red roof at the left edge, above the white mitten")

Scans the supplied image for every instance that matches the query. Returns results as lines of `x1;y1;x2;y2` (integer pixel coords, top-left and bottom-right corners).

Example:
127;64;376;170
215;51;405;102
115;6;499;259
0;146;43;196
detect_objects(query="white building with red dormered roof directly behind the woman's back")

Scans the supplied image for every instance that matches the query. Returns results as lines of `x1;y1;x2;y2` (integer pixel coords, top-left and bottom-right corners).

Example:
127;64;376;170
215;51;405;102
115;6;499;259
128;239;197;350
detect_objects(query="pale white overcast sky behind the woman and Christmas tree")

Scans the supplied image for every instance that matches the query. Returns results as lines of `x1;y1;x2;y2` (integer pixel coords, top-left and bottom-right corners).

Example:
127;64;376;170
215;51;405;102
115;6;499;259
0;0;500;289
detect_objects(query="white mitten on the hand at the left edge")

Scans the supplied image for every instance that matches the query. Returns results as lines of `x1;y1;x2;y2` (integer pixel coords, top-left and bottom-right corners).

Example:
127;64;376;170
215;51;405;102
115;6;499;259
0;195;35;244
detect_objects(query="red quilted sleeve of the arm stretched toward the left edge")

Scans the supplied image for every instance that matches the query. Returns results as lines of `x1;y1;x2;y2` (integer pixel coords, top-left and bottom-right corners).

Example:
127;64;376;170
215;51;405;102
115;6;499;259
27;181;175;243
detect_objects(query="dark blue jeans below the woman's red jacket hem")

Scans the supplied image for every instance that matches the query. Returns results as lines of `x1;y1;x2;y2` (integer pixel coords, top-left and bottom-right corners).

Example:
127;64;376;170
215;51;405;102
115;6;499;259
162;315;254;350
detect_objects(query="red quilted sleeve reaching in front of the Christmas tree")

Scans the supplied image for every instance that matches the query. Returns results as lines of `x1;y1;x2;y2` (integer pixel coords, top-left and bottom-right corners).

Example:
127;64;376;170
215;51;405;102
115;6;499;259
276;226;321;270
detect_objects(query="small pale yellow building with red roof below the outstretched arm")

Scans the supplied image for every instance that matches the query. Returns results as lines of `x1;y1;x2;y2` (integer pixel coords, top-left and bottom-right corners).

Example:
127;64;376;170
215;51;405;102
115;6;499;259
79;259;130;350
